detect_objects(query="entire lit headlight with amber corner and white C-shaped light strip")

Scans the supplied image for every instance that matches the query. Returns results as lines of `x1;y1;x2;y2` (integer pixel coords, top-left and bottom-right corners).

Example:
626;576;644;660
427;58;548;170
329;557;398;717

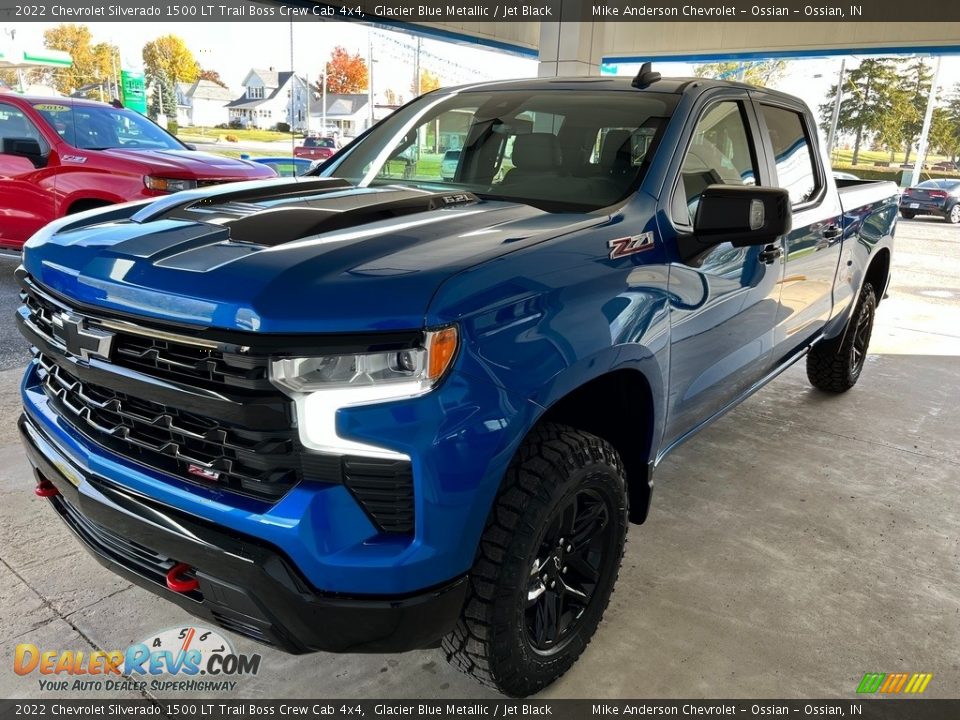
270;326;459;460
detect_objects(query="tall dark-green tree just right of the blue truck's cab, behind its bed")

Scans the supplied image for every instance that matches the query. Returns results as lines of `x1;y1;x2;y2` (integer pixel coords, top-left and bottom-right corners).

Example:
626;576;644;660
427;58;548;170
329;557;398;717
820;58;900;165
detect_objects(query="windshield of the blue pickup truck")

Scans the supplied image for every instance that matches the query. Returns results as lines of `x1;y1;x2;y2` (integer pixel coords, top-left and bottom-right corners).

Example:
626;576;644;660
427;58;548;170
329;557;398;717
322;90;677;212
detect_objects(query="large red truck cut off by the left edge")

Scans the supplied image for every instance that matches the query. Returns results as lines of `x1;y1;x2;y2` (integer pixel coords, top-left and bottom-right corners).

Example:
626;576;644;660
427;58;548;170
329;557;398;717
0;93;276;250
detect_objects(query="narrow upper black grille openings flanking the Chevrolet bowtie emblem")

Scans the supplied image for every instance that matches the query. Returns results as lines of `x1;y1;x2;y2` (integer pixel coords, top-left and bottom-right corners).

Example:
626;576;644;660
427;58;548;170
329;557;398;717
20;290;276;392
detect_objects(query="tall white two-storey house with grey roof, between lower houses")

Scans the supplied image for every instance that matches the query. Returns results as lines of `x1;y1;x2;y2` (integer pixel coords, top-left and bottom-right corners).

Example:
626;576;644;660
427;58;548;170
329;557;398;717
226;68;309;130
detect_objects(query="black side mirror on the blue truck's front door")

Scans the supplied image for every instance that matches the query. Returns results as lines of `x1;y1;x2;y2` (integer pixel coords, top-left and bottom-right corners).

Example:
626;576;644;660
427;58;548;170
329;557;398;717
693;185;793;247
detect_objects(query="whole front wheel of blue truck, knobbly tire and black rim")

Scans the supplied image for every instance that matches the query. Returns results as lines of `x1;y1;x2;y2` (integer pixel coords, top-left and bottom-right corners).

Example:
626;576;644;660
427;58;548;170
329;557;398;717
443;424;627;697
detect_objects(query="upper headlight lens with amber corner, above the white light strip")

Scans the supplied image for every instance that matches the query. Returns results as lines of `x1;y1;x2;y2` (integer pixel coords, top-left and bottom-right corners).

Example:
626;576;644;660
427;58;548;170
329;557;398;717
270;327;457;399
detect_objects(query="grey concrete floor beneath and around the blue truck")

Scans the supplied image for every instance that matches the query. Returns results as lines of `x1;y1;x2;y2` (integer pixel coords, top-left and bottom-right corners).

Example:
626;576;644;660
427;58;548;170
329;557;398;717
0;220;960;698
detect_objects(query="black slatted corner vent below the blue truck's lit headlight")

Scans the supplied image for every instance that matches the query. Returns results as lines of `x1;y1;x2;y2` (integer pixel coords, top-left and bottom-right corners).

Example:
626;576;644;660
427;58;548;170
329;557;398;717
343;457;414;533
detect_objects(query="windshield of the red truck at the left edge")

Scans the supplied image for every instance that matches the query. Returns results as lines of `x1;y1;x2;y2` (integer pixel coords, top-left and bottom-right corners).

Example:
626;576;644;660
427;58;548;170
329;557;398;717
33;103;185;150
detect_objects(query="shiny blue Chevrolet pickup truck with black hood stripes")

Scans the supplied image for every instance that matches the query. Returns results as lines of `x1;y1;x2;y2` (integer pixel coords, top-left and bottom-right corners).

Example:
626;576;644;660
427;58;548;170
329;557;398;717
18;69;898;696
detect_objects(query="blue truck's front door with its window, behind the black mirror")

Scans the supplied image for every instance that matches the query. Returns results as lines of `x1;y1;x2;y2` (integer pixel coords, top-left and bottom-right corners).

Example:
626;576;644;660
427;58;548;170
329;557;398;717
664;100;781;447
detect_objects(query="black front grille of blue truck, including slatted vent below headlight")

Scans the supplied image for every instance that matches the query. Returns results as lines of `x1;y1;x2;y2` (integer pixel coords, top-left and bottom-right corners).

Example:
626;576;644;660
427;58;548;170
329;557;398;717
20;276;414;533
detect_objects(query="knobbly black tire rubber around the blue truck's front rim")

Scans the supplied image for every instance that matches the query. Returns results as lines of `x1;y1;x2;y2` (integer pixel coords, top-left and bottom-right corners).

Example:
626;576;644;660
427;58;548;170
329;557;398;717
442;423;627;697
